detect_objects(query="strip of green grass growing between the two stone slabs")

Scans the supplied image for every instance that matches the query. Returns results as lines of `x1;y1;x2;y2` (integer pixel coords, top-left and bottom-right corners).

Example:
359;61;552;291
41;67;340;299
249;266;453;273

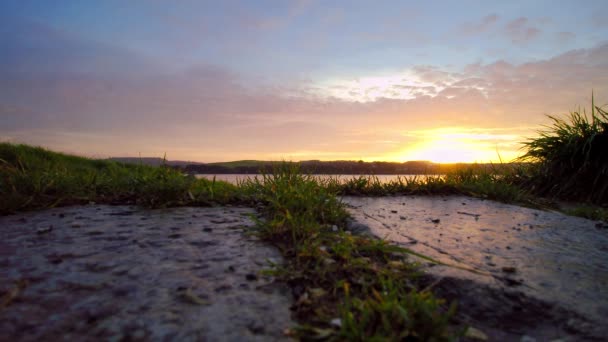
241;164;458;341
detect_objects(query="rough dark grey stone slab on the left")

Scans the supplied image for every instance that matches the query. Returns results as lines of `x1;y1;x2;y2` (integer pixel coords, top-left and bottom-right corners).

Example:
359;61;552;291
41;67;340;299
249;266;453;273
0;205;294;341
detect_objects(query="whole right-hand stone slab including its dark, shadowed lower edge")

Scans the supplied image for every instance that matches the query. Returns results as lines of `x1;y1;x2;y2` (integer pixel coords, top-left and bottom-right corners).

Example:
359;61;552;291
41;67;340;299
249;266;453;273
343;196;608;340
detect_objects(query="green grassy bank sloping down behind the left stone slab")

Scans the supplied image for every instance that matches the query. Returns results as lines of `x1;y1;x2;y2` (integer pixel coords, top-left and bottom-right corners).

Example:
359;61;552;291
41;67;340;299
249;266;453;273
0;143;242;214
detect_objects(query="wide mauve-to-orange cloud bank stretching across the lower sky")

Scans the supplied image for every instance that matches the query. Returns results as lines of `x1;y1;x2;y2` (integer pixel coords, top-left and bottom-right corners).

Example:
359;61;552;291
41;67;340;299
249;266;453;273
0;12;608;161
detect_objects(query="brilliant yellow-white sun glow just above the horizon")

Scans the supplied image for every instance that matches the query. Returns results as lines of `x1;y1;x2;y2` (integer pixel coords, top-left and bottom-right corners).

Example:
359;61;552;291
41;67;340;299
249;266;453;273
399;128;521;163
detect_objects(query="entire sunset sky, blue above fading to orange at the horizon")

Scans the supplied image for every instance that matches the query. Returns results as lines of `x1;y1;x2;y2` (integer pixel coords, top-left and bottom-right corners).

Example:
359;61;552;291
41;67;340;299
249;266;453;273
0;0;608;162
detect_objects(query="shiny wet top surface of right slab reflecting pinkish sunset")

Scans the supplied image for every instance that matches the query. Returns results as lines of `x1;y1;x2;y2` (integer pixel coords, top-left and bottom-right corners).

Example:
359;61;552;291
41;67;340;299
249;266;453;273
343;196;608;338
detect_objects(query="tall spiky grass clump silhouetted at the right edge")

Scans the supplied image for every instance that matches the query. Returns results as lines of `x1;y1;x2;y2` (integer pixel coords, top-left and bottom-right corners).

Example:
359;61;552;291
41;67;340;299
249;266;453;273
522;97;608;205
